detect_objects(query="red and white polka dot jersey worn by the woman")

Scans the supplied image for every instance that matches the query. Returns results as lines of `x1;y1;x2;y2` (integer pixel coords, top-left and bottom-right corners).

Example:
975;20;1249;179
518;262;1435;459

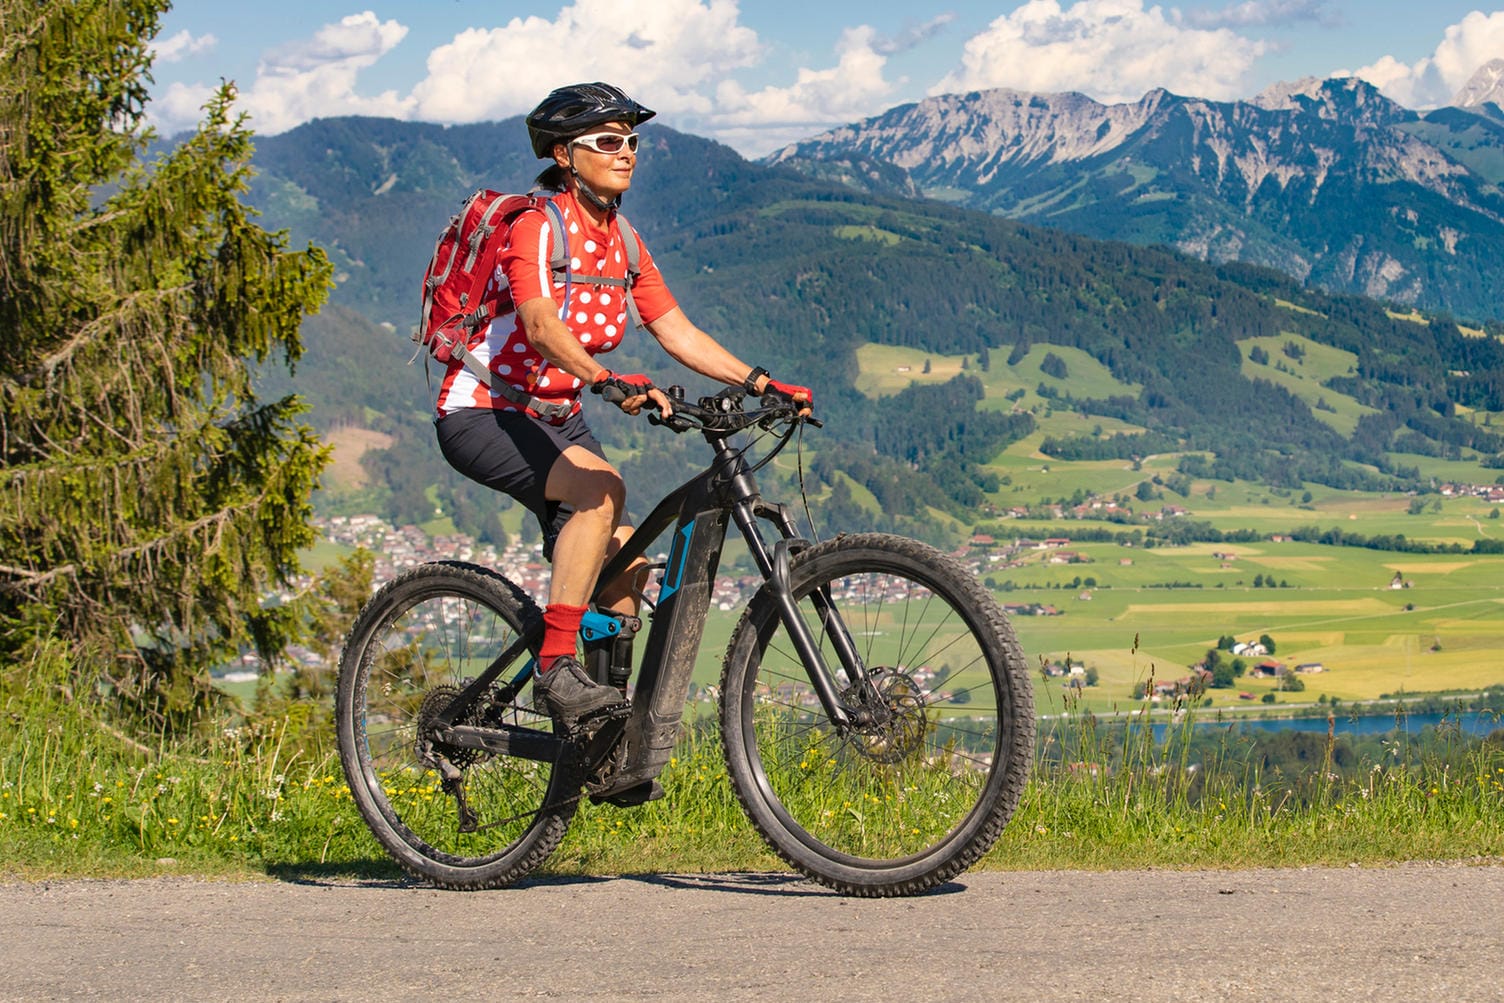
438;192;678;418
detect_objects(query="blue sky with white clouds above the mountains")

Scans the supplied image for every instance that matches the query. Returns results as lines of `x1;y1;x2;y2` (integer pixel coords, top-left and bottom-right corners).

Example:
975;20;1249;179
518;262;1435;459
152;0;1504;156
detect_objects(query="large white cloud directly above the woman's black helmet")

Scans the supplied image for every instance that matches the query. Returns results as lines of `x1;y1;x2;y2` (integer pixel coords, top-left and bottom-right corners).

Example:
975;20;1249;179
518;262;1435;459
412;0;763;122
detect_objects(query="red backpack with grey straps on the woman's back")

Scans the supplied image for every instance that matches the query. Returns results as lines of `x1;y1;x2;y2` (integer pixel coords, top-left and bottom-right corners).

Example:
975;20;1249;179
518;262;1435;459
412;188;641;403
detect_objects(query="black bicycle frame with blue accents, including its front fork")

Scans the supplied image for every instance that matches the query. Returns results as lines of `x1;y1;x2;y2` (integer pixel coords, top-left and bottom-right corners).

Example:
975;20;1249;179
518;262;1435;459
436;409;869;789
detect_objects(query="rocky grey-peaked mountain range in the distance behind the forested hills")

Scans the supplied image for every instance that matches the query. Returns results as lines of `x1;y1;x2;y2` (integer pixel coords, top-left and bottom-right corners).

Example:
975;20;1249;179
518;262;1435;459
766;69;1504;319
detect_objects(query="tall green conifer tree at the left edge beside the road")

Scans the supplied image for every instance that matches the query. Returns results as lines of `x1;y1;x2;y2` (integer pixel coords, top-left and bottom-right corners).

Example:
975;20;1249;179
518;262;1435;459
0;0;331;728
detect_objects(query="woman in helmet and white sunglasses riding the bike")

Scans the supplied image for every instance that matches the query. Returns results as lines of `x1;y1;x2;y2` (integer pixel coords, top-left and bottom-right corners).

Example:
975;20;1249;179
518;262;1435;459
436;83;814;728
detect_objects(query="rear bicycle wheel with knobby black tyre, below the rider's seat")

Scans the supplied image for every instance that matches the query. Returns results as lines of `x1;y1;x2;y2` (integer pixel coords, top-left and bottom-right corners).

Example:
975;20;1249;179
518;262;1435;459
335;564;581;889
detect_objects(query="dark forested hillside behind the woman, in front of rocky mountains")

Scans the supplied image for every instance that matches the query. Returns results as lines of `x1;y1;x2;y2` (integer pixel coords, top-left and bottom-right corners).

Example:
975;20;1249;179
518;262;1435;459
254;119;1504;541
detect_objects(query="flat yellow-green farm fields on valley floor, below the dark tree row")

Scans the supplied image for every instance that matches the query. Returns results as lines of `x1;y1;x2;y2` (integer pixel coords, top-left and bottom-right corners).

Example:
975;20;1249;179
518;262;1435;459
679;543;1504;714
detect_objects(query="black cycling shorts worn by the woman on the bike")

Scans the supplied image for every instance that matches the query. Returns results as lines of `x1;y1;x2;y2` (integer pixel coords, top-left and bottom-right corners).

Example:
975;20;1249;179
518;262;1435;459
435;408;606;559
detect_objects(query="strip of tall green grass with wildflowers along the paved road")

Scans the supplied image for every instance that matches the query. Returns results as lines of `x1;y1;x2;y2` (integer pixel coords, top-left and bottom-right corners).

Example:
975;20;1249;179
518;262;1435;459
0;652;1504;878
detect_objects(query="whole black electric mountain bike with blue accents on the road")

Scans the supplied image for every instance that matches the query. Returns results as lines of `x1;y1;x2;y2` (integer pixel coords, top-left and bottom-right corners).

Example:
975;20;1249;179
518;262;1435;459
335;388;1035;896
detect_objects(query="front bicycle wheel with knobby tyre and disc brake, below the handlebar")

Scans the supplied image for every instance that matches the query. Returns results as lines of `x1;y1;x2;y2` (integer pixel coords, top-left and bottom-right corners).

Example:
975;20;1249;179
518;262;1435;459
720;534;1035;896
